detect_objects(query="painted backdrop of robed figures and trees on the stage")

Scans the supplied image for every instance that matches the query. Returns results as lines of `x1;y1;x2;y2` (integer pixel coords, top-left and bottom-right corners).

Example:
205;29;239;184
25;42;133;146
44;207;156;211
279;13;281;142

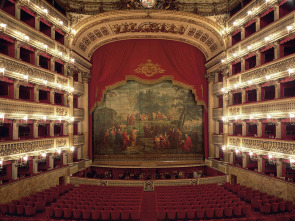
92;81;204;155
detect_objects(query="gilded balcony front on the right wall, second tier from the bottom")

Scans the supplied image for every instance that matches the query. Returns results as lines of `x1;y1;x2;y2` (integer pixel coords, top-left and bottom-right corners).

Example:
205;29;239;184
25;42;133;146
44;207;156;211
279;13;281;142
228;97;295;119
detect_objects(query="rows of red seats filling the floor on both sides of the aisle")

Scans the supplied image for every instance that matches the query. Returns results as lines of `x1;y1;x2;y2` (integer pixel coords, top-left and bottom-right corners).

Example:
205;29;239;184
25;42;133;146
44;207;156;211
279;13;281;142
0;183;295;221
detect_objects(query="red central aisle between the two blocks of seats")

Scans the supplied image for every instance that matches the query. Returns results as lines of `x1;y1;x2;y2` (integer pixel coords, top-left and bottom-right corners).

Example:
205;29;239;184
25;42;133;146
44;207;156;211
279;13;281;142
140;192;157;221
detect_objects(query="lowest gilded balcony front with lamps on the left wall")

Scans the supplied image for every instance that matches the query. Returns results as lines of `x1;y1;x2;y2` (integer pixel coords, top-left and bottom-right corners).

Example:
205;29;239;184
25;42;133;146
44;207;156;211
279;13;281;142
0;136;69;160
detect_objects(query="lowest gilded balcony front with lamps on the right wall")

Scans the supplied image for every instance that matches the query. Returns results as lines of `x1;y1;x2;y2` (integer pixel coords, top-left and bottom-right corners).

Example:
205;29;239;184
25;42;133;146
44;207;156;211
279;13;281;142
227;136;295;155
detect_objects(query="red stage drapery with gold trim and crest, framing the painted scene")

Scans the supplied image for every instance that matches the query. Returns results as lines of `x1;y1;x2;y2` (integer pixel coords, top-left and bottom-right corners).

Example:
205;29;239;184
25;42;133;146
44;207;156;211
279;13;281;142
89;39;208;157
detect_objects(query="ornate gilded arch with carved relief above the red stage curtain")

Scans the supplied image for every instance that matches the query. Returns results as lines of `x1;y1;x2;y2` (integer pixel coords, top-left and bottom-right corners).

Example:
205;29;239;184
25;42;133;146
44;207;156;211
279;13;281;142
71;10;225;61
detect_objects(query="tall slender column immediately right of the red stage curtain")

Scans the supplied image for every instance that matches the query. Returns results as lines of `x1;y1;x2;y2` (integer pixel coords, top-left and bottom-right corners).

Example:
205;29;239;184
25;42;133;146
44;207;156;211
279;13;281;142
208;77;214;157
